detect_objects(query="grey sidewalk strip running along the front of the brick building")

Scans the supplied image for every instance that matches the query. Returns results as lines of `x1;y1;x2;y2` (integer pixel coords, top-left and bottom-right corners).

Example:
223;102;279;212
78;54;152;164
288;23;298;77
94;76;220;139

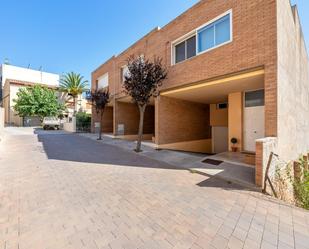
78;133;258;190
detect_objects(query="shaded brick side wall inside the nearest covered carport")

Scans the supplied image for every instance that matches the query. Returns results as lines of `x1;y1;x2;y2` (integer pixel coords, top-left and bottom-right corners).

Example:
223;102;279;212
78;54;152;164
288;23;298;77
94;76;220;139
155;96;211;145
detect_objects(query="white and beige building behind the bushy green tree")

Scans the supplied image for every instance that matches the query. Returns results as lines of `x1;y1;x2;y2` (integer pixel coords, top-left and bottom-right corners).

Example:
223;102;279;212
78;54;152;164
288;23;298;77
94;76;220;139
0;64;59;126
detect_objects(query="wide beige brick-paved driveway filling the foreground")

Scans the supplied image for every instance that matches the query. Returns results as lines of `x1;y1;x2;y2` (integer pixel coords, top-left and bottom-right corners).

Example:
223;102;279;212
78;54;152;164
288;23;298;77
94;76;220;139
0;128;309;249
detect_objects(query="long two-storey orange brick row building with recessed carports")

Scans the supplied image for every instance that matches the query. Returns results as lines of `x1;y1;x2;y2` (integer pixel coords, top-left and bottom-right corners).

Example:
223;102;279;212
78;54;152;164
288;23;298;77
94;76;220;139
92;0;309;186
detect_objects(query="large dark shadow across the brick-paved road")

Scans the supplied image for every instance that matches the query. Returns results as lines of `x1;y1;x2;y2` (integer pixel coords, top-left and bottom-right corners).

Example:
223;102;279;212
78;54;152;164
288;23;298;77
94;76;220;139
34;129;183;170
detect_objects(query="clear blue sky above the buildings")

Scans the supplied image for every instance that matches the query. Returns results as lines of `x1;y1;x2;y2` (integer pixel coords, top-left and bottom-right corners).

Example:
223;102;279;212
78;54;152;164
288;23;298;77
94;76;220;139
0;0;309;84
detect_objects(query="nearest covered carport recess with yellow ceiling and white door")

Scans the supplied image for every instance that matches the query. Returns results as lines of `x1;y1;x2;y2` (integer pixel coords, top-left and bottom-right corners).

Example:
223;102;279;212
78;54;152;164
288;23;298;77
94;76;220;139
155;68;265;165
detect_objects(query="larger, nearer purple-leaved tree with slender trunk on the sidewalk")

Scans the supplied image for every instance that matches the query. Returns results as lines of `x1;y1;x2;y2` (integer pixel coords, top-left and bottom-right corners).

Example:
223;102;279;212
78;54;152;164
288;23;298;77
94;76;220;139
123;56;167;152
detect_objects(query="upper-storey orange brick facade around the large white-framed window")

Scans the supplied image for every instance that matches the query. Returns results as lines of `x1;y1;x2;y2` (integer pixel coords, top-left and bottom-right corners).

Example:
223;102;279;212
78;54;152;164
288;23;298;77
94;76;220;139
92;0;277;136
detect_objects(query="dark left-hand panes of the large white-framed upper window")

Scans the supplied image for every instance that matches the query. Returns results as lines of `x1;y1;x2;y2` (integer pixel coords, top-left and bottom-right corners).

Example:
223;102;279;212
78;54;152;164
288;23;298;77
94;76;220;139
175;36;196;63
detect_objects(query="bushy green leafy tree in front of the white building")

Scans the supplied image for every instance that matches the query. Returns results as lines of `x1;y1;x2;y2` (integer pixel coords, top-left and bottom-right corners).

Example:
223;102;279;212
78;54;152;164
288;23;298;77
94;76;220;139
13;85;64;121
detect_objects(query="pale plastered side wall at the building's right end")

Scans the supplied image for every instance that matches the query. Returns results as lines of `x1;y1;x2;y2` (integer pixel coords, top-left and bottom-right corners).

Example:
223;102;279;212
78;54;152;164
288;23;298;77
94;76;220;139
277;0;309;161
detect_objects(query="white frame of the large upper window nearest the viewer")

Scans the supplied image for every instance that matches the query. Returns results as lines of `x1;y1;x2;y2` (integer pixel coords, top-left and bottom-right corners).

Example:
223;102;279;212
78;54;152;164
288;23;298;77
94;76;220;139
171;9;233;66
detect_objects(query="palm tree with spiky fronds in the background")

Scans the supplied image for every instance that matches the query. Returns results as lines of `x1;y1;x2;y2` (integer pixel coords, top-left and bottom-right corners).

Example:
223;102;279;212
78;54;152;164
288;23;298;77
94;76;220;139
60;72;88;115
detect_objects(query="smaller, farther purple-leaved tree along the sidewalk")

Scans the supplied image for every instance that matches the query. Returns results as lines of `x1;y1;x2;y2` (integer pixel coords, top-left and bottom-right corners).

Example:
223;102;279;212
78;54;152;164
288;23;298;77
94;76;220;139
90;89;110;140
